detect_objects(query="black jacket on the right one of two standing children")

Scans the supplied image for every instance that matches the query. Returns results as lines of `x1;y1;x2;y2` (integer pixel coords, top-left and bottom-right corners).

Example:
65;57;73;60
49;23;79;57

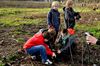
63;7;81;28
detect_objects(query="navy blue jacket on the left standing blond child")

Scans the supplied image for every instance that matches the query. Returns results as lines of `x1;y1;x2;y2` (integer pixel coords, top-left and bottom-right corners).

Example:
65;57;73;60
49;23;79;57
47;9;60;31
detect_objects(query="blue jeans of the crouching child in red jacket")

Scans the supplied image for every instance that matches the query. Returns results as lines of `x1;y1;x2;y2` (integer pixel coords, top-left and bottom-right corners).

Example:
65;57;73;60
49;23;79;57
26;45;47;62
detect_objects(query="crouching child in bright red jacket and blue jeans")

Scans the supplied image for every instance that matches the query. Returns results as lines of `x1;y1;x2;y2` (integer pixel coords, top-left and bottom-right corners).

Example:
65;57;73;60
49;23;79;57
23;31;56;64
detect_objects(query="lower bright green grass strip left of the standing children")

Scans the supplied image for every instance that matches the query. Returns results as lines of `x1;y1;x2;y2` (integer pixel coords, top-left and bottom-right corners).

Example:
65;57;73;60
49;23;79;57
0;17;43;26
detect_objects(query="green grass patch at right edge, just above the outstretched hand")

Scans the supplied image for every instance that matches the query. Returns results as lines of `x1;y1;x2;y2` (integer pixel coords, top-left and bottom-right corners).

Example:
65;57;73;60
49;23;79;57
76;21;100;38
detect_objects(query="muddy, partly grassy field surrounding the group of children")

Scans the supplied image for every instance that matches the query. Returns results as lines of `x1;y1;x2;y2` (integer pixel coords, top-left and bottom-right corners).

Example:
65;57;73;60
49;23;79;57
0;7;100;66
